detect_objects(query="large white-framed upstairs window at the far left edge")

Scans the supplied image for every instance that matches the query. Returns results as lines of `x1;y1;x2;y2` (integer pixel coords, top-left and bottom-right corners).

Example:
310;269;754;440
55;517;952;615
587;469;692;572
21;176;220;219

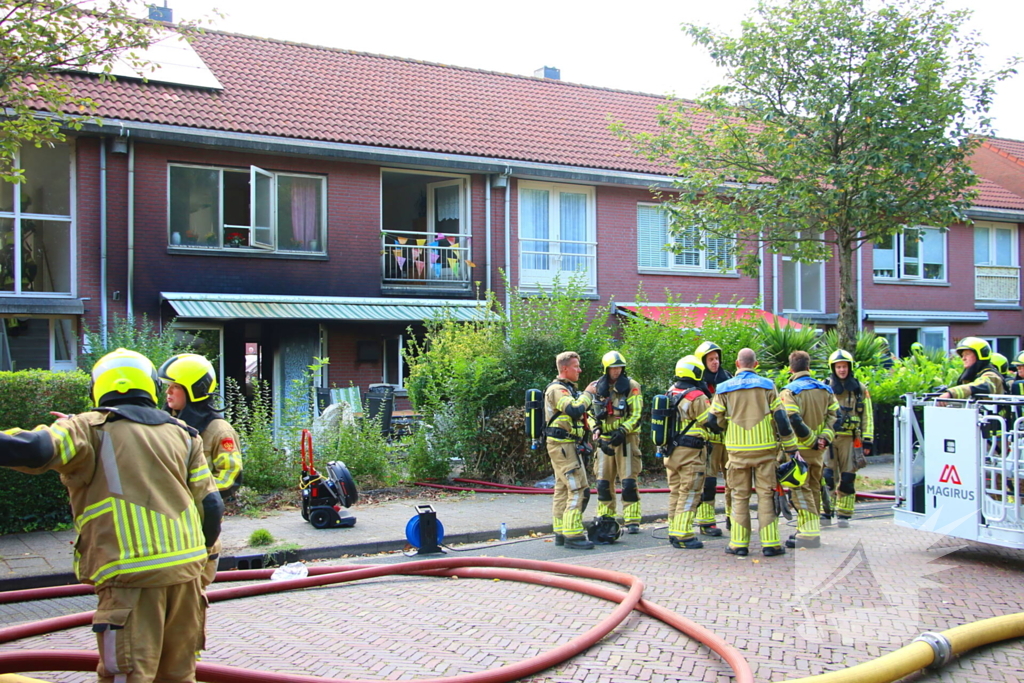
0;144;77;296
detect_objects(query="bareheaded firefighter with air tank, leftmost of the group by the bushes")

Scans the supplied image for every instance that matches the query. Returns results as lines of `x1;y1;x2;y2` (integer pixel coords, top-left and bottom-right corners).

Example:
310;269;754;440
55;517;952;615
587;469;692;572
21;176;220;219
544;351;596;550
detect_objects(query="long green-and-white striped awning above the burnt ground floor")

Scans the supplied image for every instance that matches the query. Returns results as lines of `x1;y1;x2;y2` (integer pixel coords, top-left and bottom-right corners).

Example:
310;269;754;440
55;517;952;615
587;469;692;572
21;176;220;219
160;292;490;323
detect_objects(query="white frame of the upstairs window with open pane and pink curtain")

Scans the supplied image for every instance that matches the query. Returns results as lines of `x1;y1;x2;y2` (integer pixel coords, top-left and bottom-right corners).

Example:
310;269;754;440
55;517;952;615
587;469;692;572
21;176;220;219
167;163;328;255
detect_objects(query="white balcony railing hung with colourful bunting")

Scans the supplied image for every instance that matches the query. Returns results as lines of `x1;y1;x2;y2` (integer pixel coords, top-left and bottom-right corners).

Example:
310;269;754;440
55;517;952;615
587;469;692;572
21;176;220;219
381;230;473;290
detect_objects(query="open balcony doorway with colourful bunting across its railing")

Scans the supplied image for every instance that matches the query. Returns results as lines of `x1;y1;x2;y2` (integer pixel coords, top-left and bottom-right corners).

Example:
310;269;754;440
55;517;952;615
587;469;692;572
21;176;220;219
380;170;473;292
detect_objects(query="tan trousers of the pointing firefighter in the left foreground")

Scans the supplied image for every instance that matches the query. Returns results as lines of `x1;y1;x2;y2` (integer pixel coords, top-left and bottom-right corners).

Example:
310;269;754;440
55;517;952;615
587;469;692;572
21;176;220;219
92;578;206;683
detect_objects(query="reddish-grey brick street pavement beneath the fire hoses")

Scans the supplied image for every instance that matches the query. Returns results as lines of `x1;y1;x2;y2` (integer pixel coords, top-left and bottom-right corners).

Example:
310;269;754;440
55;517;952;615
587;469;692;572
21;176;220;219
0;515;1024;683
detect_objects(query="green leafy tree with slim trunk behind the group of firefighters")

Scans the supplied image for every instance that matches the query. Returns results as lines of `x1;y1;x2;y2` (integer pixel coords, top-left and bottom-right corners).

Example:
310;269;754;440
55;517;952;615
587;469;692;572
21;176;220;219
616;0;1017;348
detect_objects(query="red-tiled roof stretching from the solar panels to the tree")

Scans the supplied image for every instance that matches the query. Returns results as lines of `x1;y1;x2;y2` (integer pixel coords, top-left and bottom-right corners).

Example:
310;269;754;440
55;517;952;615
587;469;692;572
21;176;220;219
67;31;688;174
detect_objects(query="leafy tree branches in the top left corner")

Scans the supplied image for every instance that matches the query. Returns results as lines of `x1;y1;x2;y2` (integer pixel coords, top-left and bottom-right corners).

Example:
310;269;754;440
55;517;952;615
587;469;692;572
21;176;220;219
0;0;196;182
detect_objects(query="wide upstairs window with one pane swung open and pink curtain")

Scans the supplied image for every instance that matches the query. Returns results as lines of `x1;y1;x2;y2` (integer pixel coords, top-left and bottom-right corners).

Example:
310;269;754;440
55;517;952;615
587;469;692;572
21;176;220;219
168;164;327;253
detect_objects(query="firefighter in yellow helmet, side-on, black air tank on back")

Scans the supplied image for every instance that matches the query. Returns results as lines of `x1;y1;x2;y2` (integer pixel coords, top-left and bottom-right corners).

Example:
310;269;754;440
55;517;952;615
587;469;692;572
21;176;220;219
665;355;710;550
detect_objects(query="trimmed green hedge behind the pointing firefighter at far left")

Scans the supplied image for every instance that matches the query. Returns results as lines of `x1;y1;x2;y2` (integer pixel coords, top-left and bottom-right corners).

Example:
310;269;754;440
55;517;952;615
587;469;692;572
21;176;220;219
0;370;92;533
